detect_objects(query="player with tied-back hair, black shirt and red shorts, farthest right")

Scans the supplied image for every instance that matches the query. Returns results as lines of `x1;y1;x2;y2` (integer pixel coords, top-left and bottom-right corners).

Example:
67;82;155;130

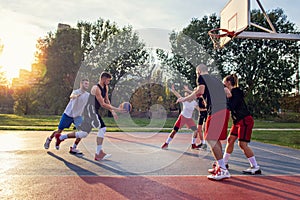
223;74;261;174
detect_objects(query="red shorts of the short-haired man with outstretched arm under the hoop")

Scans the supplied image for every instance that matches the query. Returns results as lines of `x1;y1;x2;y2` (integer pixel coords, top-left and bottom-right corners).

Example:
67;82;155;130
204;109;230;140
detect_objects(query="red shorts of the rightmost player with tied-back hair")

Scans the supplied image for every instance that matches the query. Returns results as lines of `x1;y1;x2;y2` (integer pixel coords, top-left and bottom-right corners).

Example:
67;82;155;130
230;115;254;142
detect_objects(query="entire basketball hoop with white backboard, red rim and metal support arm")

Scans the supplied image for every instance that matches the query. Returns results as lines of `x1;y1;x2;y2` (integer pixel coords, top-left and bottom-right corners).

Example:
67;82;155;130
212;0;300;49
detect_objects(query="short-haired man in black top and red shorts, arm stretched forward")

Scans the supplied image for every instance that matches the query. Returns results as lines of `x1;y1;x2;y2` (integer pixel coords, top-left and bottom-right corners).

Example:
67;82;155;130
177;64;230;180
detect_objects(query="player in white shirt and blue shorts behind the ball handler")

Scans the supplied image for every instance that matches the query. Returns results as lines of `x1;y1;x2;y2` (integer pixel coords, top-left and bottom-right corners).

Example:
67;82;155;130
44;79;89;154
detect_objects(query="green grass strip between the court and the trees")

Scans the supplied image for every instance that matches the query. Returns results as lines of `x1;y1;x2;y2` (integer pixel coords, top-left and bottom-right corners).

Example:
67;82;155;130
0;114;300;149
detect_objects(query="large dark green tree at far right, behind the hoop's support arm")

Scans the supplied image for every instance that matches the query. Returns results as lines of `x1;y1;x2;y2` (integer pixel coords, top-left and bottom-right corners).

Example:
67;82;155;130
221;9;299;117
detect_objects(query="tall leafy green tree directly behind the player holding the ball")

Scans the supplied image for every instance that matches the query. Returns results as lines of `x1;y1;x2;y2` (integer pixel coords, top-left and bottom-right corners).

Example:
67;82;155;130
76;19;149;115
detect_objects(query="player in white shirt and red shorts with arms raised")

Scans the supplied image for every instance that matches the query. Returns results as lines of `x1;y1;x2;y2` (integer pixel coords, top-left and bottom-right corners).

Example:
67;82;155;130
161;85;199;149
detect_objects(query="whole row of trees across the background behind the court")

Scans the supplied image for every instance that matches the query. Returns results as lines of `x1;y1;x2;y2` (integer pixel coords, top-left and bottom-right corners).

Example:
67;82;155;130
1;8;300;117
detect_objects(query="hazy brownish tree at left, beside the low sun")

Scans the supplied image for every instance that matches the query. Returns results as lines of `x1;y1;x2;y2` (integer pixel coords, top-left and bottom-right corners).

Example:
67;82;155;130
36;28;82;114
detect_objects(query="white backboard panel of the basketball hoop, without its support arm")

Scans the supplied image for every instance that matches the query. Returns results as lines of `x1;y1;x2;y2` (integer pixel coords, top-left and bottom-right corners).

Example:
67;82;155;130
220;0;250;48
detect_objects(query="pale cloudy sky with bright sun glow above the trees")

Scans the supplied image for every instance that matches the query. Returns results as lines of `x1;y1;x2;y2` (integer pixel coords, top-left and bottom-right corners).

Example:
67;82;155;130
0;0;300;79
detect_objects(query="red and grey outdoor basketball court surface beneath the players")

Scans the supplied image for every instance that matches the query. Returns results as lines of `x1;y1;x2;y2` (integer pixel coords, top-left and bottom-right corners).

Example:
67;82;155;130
0;131;300;199
